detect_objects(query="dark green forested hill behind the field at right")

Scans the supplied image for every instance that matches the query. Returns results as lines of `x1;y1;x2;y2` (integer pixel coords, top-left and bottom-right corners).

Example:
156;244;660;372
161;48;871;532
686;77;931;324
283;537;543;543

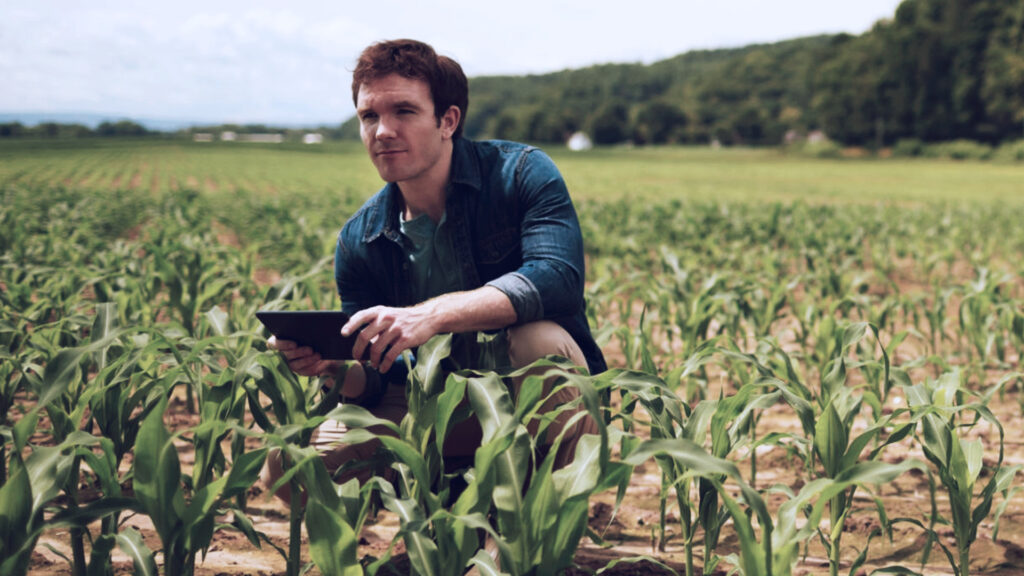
346;0;1024;146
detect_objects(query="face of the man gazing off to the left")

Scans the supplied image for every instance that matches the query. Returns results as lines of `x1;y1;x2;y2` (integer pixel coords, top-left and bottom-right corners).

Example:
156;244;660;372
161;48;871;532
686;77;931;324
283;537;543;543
355;74;459;183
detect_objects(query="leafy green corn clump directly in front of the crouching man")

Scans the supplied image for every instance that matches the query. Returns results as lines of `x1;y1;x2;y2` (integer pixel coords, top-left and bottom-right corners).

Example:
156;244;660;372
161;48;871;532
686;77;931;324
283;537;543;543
319;336;631;575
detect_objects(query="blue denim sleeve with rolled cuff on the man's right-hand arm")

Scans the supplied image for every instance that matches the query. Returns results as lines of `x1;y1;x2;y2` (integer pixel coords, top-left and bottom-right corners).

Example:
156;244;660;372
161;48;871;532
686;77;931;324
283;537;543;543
487;149;585;324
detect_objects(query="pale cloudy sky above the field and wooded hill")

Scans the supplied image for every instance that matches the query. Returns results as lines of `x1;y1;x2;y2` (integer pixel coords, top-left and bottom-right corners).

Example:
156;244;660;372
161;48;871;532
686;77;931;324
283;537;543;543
6;0;899;125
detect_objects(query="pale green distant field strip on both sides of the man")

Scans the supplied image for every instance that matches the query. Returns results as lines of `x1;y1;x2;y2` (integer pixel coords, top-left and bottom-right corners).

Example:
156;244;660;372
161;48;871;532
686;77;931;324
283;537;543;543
0;139;1024;203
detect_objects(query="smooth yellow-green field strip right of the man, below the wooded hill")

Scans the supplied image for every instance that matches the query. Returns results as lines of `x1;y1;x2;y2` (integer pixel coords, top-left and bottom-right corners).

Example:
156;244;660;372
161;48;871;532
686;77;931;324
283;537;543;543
551;148;1024;203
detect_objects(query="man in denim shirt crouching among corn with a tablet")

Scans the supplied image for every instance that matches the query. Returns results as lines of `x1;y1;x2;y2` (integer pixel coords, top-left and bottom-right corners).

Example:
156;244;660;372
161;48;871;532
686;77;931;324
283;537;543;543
269;40;606;494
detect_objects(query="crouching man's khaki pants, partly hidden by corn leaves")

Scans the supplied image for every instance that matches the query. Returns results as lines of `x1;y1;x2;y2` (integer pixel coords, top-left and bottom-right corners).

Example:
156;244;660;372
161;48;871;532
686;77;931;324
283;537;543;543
263;321;597;501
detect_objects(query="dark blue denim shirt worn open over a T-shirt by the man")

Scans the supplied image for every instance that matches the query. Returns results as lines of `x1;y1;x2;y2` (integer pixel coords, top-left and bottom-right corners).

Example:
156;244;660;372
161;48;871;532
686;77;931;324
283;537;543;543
334;137;607;374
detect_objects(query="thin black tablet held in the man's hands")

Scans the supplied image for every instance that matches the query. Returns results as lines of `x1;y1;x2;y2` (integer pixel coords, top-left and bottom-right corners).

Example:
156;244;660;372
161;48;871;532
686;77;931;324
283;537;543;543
256;310;369;360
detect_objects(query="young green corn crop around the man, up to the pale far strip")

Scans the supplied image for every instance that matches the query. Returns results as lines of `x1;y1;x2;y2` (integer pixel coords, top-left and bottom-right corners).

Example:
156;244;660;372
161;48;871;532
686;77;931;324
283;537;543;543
0;179;1024;576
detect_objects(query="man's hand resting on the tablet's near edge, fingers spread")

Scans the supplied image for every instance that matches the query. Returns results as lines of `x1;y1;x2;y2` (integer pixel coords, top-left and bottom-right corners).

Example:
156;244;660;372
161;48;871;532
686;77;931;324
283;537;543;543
341;302;439;373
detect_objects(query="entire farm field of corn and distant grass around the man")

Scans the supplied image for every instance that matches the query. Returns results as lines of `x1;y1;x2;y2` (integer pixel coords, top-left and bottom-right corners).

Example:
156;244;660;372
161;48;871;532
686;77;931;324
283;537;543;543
0;140;1024;576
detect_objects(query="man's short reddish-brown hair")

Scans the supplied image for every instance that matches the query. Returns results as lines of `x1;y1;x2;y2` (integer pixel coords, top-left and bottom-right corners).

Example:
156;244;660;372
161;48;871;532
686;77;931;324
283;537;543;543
352;40;469;137
